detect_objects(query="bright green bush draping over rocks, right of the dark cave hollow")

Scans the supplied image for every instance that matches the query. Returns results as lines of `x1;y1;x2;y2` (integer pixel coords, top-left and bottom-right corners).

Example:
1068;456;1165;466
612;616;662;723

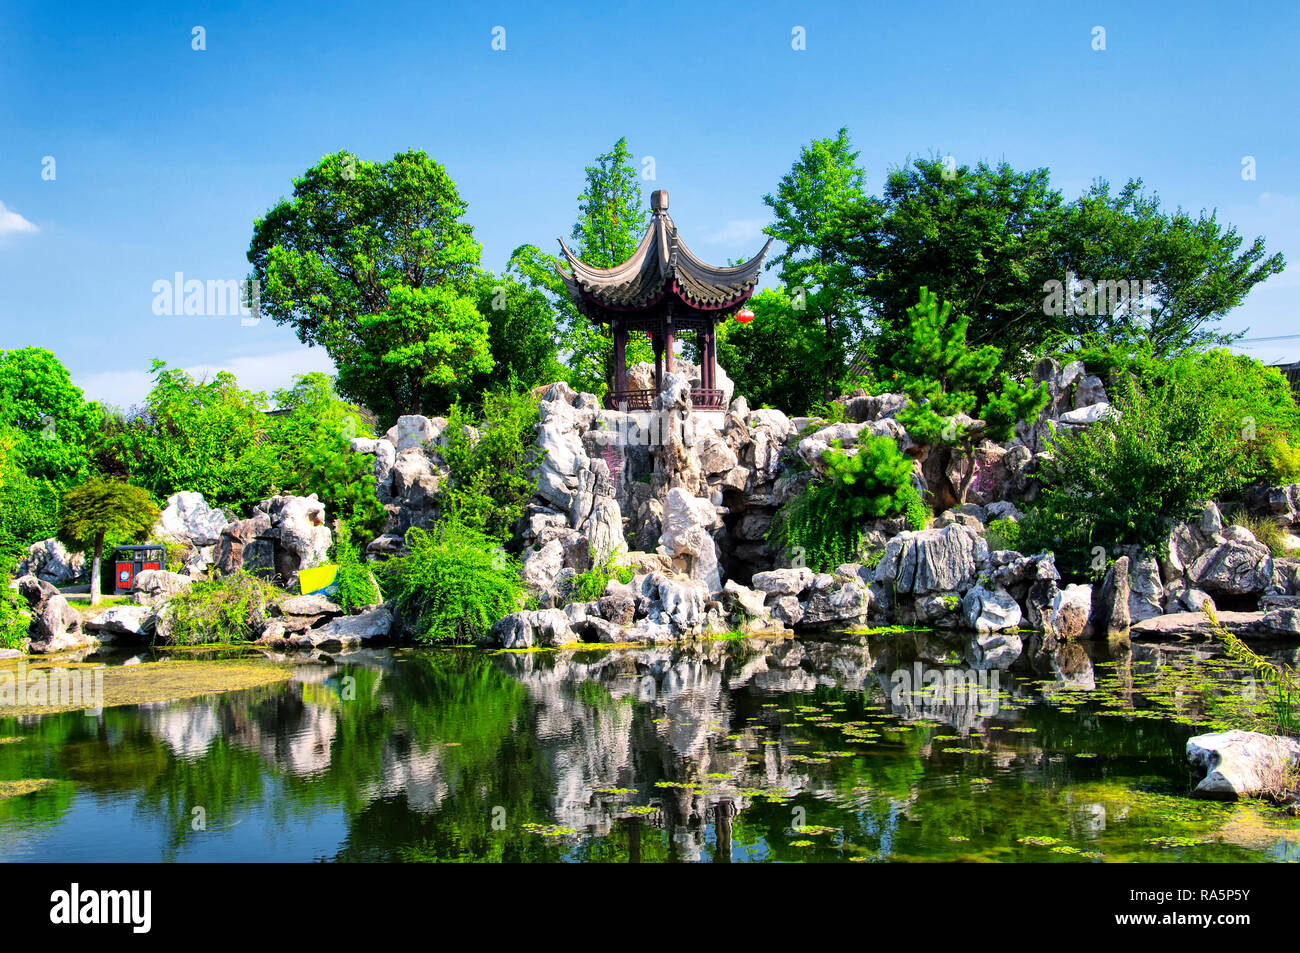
770;437;928;572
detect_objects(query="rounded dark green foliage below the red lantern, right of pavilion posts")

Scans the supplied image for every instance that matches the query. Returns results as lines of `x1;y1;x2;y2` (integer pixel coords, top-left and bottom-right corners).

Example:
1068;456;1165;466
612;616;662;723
718;289;827;415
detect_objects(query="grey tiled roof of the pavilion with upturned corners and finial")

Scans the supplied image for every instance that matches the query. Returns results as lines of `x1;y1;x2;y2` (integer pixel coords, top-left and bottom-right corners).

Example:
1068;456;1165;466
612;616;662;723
555;190;772;317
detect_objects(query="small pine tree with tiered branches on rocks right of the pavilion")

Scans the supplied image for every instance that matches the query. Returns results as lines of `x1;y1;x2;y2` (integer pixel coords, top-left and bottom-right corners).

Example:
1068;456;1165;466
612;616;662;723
894;287;1049;503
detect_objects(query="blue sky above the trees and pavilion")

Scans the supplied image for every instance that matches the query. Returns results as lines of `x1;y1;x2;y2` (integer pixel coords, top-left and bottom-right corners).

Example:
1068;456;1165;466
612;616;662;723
0;0;1300;404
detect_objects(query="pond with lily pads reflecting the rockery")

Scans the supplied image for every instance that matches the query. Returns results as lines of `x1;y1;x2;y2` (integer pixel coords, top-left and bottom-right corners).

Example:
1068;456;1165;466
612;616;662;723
0;632;1300;863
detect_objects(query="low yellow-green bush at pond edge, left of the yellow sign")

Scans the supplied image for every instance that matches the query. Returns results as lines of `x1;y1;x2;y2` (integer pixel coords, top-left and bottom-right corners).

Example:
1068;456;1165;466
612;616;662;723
166;569;285;645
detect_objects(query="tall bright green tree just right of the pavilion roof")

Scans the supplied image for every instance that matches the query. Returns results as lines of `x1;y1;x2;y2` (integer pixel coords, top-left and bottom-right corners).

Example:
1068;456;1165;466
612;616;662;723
755;129;880;397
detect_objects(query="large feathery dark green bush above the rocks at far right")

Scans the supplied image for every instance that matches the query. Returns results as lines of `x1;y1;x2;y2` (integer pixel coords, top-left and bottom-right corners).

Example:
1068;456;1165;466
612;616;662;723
1022;378;1239;573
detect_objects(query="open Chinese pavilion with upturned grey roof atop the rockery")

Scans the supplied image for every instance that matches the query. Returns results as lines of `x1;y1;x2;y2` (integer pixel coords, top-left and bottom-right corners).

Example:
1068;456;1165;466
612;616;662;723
555;189;772;411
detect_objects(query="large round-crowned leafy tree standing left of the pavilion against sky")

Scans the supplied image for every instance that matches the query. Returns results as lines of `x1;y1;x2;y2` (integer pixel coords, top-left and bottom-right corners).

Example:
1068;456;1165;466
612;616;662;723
248;151;491;423
